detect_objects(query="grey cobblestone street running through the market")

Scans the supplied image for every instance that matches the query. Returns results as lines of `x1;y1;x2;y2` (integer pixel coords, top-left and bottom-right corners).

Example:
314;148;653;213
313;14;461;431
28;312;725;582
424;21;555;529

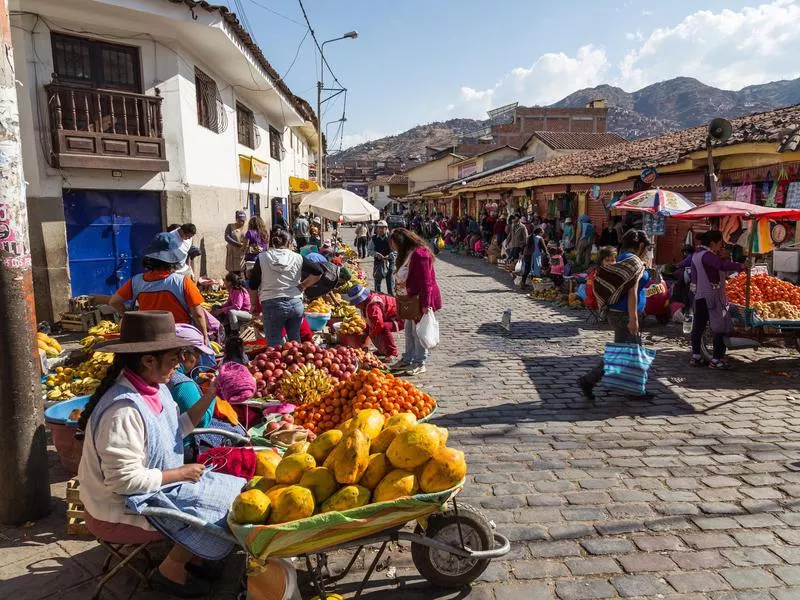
0;245;800;600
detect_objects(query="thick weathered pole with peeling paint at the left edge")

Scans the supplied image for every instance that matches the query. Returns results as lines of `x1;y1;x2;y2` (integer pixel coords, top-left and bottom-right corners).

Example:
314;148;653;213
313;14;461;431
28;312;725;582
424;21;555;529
0;0;50;525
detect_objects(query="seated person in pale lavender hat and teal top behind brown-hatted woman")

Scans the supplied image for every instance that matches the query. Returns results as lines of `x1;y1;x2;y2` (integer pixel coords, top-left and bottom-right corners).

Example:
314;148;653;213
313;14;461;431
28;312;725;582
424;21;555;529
167;324;247;462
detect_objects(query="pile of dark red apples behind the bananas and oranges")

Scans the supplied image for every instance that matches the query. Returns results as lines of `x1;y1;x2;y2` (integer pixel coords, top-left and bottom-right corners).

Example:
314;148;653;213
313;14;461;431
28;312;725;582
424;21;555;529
250;342;358;402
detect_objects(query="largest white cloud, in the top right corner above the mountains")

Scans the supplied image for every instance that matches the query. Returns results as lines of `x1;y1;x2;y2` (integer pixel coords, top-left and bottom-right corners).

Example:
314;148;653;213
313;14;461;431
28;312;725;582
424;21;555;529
618;0;800;90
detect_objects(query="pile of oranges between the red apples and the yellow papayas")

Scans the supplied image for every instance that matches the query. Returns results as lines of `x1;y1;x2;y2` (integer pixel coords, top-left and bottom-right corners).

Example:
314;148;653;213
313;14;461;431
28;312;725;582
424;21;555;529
294;369;436;434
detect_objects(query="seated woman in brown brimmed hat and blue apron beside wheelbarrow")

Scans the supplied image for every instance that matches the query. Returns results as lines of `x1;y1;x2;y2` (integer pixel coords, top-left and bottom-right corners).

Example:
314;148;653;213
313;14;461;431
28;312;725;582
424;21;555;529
78;311;245;598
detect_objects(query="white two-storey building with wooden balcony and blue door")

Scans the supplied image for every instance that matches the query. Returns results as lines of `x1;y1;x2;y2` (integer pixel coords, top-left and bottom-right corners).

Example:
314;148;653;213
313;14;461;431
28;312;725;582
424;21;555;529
11;0;317;320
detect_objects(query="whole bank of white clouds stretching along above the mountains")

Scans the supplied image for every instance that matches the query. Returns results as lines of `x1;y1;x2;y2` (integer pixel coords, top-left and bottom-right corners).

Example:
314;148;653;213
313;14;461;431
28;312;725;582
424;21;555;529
446;0;800;118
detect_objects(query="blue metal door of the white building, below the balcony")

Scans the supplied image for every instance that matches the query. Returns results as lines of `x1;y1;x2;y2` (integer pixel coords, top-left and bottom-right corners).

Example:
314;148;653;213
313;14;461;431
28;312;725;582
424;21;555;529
64;190;162;296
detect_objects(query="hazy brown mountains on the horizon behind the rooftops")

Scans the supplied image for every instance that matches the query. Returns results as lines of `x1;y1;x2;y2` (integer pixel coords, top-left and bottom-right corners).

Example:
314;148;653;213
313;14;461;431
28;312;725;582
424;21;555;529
330;77;800;164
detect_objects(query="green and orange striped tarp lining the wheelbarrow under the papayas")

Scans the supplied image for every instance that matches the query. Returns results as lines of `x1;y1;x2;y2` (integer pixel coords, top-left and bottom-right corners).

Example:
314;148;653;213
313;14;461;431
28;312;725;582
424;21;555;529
228;480;464;560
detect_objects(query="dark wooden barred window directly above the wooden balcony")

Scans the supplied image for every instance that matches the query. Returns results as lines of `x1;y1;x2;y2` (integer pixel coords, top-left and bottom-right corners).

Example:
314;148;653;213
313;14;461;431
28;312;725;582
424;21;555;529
50;33;142;93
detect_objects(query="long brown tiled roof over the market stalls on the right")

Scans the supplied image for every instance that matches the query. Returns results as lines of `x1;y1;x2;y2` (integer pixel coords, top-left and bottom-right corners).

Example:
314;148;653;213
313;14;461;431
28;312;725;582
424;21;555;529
465;104;800;187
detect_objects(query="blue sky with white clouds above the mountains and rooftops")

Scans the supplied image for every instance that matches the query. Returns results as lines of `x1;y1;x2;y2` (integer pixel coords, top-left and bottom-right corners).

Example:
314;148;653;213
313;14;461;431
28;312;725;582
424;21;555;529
227;0;800;148
